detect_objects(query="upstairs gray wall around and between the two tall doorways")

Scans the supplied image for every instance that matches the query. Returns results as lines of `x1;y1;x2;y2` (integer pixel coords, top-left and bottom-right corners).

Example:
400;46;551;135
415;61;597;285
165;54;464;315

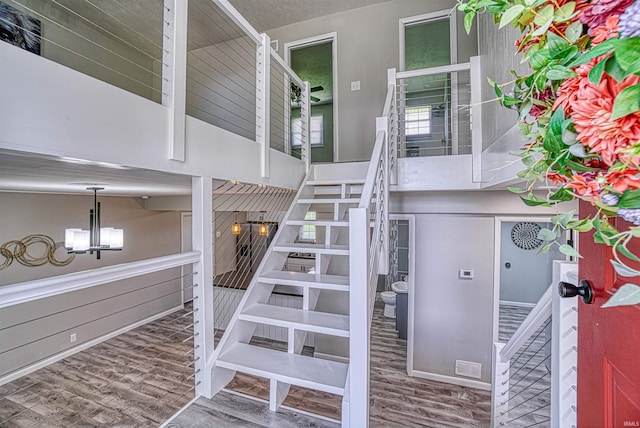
267;0;477;161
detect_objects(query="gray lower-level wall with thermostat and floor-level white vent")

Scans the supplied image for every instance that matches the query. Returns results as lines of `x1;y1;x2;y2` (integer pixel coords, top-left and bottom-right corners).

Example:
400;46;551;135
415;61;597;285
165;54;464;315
390;191;575;383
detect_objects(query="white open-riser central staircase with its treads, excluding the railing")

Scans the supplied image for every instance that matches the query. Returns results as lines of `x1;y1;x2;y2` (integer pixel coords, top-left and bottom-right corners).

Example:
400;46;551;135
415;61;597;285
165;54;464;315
209;163;368;425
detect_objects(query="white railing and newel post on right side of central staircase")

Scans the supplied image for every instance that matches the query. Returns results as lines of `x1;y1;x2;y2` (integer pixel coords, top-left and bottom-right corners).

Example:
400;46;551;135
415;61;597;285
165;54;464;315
342;85;395;427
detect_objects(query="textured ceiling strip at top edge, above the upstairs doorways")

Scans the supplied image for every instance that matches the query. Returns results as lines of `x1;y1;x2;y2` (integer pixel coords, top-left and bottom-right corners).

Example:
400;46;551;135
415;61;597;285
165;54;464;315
229;0;390;32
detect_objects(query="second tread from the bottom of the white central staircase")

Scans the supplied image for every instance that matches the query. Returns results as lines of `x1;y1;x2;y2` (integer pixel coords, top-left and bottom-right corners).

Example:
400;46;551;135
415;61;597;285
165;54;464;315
240;303;349;337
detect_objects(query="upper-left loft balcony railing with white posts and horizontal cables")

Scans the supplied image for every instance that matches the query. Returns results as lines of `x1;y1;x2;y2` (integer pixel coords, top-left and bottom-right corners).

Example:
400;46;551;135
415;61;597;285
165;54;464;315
0;0;310;177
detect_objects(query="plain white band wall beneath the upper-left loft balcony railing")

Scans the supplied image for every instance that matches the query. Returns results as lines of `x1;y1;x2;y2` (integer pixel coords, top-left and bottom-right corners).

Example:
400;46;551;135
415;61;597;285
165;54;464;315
0;43;305;188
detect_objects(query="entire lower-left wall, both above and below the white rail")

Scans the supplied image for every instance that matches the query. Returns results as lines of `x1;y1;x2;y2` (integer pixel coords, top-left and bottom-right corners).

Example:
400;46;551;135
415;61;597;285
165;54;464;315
0;193;182;376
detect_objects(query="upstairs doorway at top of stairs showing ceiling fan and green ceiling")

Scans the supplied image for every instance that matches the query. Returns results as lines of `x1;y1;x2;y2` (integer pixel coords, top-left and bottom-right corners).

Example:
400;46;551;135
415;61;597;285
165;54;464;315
284;33;337;162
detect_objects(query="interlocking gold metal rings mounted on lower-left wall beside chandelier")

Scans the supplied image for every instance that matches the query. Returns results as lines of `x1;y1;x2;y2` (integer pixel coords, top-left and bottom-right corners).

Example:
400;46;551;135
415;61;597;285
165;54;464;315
0;234;76;270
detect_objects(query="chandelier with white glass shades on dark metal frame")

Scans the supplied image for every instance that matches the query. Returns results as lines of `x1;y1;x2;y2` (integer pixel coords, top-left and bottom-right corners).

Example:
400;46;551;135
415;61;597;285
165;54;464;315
64;187;124;259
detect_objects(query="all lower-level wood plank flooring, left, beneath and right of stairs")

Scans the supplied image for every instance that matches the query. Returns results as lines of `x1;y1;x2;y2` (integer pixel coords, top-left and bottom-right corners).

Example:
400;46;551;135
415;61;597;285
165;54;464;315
0;302;490;428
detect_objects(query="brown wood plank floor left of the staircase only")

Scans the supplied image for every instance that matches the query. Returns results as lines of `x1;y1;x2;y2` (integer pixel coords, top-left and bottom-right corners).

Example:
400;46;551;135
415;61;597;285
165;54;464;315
0;310;194;427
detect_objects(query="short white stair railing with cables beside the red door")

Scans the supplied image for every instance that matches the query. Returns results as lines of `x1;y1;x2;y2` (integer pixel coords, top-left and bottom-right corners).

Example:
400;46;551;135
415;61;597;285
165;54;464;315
491;261;577;427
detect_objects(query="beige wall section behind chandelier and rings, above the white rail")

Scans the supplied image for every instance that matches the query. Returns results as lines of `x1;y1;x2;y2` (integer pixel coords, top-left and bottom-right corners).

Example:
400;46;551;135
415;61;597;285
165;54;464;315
0;192;180;286
